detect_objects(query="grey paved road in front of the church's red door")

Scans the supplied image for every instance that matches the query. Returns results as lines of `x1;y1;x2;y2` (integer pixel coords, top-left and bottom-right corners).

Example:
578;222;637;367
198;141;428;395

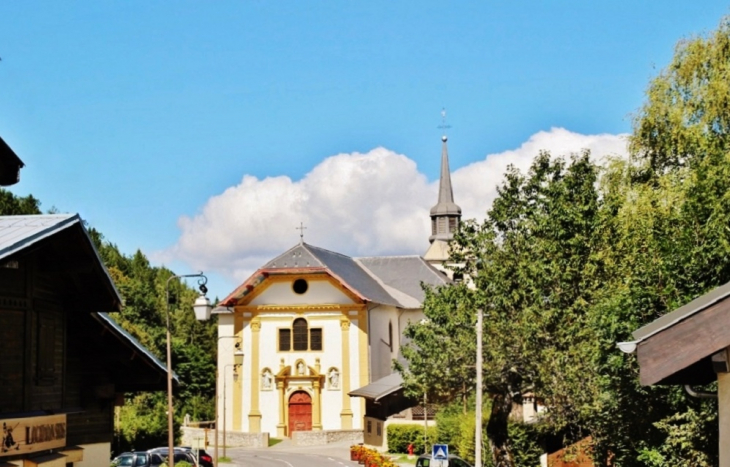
221;448;358;467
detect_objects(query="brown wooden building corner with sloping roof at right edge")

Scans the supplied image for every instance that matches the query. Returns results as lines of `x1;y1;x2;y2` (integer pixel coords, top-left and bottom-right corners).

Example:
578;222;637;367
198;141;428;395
619;283;730;467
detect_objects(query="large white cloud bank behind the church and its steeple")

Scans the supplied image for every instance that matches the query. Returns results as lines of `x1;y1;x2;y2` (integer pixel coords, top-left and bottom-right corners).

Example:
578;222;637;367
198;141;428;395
162;128;626;283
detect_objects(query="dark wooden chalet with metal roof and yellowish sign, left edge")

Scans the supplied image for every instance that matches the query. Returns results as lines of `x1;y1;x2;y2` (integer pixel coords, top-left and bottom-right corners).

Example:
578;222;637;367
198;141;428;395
0;214;166;467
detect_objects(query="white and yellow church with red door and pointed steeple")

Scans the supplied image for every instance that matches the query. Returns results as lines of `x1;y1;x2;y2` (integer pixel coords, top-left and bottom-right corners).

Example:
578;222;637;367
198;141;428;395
214;136;461;438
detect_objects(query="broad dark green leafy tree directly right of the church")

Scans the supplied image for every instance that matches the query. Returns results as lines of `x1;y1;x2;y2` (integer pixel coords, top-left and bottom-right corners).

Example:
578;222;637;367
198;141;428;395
403;152;600;467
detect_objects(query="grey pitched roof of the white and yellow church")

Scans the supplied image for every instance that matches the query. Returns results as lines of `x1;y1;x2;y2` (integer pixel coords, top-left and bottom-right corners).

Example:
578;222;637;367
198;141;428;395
220;242;449;309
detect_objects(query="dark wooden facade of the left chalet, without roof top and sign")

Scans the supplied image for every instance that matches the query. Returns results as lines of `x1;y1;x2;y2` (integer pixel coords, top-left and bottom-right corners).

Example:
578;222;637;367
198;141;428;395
0;216;166;461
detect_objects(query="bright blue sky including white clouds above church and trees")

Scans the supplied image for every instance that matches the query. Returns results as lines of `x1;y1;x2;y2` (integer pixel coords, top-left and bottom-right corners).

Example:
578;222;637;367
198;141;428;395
0;0;729;295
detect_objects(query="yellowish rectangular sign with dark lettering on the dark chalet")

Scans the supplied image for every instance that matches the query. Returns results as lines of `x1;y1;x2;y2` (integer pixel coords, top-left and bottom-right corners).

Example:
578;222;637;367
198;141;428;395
0;414;66;457
